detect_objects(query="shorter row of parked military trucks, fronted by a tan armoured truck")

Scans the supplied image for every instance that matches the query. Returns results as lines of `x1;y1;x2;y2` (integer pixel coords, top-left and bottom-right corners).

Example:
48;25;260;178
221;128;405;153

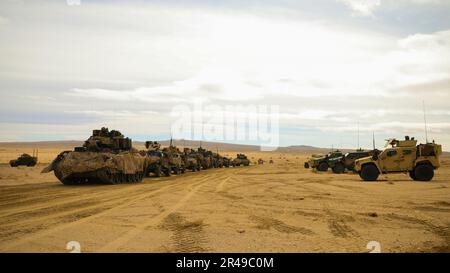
304;136;442;181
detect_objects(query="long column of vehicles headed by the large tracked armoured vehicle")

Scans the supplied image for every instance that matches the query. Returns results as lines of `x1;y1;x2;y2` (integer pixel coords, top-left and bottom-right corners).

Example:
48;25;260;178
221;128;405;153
36;128;250;185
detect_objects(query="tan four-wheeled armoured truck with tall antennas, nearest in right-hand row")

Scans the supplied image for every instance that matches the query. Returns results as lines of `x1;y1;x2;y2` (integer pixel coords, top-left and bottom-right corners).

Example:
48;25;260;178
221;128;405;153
355;136;442;181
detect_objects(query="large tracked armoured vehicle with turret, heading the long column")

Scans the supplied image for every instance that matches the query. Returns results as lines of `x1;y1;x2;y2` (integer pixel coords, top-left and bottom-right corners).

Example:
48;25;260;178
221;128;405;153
42;127;146;185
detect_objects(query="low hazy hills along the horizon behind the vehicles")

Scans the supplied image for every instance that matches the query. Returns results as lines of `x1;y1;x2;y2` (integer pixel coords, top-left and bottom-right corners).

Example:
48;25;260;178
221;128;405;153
0;139;450;156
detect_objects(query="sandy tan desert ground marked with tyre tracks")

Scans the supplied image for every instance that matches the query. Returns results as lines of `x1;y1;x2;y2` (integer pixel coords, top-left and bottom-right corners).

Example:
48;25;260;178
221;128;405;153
0;147;450;252
